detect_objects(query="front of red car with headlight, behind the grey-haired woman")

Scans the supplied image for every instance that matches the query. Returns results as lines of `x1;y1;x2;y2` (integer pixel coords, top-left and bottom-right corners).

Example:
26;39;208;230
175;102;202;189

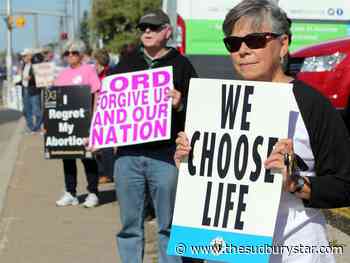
289;38;350;113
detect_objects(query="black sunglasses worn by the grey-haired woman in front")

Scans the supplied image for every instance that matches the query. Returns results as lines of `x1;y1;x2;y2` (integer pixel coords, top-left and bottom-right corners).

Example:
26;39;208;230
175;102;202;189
224;32;282;53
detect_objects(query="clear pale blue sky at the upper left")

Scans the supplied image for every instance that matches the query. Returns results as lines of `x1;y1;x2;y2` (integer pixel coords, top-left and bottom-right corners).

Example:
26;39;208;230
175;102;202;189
0;0;92;52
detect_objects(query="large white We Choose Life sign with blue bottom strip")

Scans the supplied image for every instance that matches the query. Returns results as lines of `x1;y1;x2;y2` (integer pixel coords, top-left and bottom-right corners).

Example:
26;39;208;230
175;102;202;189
168;79;295;263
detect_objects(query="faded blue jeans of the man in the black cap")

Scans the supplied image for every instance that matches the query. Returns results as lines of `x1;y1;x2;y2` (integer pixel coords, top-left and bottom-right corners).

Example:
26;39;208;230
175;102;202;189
114;148;182;263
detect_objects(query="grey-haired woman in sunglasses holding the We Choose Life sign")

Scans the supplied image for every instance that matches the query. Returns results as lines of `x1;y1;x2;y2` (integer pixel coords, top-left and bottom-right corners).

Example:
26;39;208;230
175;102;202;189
175;0;350;263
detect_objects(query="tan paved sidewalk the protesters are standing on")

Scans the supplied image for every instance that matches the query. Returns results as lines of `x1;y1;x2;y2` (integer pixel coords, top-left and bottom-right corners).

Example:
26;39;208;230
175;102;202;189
0;115;156;263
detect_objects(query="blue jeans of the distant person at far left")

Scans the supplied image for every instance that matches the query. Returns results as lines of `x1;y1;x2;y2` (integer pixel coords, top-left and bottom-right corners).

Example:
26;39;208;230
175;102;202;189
23;88;43;132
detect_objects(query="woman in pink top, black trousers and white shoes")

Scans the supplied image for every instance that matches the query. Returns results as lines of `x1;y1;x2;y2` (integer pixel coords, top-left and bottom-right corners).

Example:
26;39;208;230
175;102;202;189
54;40;101;207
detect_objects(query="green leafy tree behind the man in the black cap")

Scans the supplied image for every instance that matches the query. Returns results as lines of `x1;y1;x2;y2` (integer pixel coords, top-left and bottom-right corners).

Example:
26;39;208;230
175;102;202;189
90;0;161;52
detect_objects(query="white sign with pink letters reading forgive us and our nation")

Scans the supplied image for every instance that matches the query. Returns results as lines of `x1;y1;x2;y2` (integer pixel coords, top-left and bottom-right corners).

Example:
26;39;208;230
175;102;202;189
89;67;173;148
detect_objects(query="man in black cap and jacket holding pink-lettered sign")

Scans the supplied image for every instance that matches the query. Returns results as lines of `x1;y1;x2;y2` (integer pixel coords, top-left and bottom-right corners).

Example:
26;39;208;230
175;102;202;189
111;10;196;263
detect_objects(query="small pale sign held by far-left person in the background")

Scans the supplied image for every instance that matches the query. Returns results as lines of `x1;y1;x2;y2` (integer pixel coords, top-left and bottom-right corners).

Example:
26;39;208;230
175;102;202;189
33;62;63;87
